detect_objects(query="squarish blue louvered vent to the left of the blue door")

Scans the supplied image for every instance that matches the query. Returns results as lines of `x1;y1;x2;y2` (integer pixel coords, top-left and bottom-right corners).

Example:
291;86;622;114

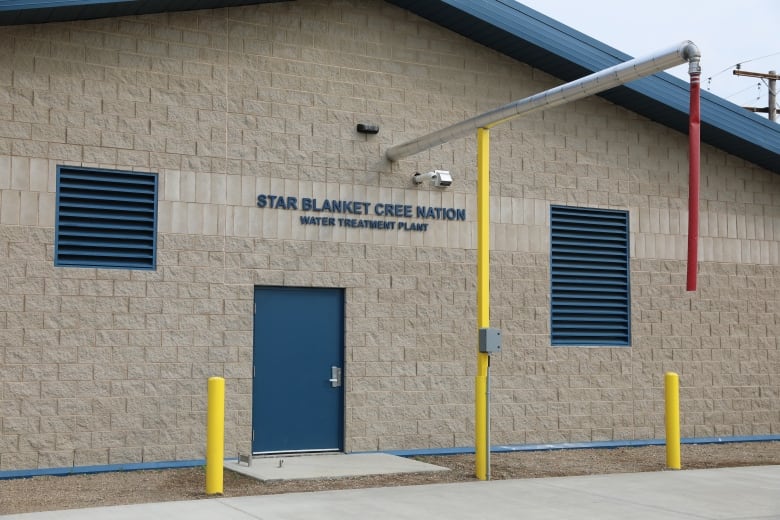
54;166;157;269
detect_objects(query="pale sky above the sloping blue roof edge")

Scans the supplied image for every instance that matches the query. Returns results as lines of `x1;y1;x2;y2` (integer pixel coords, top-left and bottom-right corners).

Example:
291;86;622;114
521;0;780;117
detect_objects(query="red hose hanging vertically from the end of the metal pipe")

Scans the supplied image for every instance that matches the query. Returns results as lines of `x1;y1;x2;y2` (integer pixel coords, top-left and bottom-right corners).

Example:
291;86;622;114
686;71;701;291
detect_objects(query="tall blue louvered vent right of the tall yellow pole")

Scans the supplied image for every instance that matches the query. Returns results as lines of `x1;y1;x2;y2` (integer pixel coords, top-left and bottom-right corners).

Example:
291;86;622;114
550;206;631;346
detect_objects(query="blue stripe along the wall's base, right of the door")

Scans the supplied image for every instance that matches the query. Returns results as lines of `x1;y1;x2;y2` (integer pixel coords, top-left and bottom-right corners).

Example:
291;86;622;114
383;435;780;457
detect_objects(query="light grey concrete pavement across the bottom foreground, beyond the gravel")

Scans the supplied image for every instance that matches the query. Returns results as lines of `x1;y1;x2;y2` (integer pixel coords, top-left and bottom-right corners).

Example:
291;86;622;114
2;466;780;520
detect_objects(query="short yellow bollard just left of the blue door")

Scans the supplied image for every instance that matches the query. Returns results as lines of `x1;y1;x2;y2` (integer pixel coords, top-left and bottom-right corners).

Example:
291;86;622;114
206;377;225;495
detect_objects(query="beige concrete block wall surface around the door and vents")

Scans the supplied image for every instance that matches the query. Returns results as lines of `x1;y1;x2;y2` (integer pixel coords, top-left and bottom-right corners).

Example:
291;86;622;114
0;0;780;470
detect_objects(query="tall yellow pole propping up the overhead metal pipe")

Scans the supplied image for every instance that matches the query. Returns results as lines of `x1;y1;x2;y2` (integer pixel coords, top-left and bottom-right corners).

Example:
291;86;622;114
474;128;490;480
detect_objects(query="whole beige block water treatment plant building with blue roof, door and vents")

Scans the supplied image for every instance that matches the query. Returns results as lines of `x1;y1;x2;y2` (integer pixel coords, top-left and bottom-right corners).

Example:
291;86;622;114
0;0;780;472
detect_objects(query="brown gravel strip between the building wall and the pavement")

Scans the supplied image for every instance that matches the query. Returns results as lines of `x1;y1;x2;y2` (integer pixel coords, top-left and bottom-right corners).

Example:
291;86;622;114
0;442;780;515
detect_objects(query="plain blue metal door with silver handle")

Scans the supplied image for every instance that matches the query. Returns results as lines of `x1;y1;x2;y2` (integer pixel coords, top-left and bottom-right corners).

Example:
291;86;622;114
252;287;344;453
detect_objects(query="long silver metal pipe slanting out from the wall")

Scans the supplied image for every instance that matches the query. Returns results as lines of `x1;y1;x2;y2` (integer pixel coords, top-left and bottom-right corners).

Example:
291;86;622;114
386;40;700;161
